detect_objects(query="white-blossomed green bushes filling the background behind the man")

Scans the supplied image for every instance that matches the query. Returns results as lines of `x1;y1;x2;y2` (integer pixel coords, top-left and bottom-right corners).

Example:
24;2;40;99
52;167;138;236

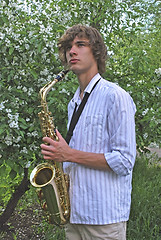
0;0;160;178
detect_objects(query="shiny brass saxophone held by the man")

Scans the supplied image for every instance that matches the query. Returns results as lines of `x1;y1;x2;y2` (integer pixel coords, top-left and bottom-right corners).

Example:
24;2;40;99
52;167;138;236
30;70;70;226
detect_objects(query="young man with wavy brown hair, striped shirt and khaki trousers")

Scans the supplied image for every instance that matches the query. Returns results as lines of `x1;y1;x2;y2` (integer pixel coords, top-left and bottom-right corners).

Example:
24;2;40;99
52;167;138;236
41;25;136;240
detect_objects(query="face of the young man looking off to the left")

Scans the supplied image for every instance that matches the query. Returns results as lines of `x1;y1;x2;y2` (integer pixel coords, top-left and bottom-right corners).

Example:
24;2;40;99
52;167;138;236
66;36;97;75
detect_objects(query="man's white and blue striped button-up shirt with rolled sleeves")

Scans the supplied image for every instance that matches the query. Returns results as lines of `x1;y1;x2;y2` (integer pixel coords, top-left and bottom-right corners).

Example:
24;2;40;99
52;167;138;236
63;74;136;225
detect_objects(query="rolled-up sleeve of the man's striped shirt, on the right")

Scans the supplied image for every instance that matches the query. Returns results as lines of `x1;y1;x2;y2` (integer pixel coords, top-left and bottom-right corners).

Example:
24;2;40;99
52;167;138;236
104;89;136;175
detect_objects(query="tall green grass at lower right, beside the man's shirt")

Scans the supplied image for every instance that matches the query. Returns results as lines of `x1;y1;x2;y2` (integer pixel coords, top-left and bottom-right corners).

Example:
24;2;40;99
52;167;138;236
127;156;161;240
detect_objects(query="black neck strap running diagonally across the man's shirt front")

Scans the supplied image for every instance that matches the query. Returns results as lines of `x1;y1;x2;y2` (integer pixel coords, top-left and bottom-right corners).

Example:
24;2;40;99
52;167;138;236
65;79;100;144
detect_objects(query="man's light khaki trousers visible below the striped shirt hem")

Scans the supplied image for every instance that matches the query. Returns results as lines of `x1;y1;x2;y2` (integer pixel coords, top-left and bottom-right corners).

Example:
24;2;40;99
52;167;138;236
65;222;126;240
